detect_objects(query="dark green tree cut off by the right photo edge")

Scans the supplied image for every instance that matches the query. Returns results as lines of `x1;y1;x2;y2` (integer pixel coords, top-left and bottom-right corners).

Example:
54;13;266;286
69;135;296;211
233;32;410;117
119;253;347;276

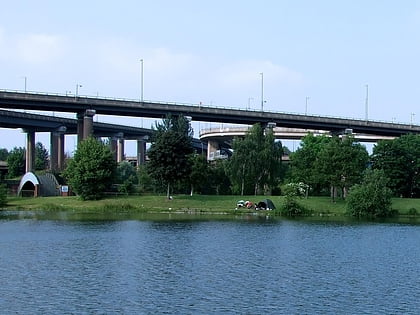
372;135;420;198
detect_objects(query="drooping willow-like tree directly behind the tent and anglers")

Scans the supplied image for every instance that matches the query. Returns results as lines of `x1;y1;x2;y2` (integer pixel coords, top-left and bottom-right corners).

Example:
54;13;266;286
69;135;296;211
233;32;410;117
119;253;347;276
227;124;283;195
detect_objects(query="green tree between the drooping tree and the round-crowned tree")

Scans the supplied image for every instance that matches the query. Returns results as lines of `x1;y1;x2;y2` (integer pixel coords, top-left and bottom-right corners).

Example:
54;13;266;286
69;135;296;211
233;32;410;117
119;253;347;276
290;133;331;192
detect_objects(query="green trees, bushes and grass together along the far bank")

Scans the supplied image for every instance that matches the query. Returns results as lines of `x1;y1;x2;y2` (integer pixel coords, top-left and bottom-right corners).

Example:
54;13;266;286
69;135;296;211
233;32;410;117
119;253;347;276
0;116;420;217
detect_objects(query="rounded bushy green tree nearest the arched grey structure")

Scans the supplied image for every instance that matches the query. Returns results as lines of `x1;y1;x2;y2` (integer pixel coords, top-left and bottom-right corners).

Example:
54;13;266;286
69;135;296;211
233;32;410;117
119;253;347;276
64;138;116;200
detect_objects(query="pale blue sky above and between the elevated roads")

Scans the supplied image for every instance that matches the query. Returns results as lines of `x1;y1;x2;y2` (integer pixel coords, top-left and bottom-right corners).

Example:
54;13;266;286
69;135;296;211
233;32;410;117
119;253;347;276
0;0;420;155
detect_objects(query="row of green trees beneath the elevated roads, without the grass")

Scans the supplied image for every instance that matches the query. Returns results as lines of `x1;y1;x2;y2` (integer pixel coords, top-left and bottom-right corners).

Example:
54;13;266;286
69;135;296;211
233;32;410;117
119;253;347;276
0;116;420;217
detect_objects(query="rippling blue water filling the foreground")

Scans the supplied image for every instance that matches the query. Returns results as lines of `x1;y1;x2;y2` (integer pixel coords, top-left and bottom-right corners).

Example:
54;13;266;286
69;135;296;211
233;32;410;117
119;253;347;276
0;213;420;314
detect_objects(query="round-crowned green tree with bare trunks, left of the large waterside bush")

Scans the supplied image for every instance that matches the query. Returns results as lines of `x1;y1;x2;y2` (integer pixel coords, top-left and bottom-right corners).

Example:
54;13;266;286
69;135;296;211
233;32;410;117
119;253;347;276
315;137;369;201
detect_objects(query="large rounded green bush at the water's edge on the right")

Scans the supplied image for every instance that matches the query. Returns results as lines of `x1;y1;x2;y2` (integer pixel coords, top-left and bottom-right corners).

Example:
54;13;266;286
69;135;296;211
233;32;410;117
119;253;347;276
347;170;392;217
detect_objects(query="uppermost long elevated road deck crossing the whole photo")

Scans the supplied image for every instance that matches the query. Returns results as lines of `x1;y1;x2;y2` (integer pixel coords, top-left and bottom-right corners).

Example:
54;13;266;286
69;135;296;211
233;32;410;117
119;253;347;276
0;90;420;137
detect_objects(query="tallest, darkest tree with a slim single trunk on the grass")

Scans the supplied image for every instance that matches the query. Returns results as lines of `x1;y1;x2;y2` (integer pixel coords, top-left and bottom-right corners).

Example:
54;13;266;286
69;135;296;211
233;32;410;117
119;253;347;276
147;116;193;198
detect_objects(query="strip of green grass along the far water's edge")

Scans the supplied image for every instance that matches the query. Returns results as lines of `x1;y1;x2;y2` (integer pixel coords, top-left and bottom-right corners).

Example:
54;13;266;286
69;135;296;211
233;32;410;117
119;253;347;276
5;195;420;215
